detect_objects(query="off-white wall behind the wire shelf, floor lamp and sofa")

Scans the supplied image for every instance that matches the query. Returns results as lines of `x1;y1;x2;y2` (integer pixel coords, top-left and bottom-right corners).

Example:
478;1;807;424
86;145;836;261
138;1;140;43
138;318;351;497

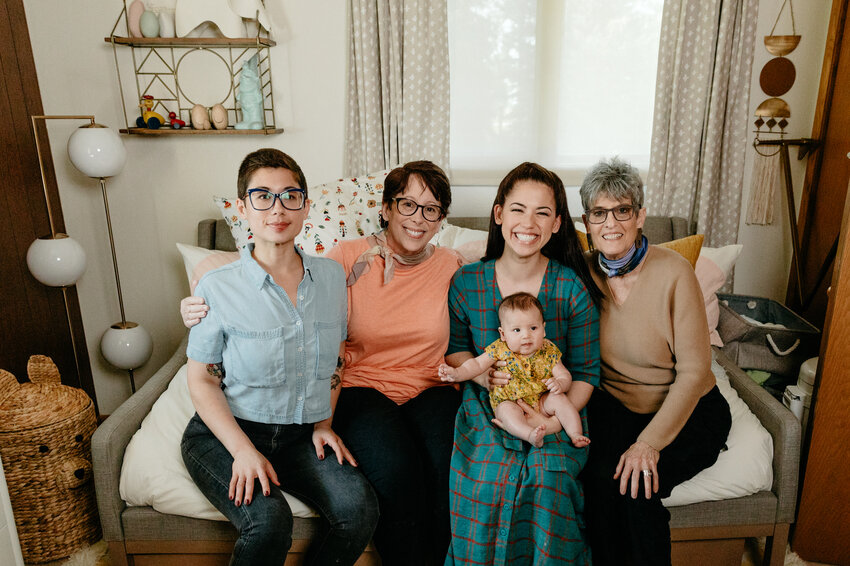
24;0;830;413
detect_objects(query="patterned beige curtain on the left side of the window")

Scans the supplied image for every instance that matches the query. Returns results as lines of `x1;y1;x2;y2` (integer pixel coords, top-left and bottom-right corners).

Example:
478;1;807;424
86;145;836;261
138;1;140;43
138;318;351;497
345;0;449;176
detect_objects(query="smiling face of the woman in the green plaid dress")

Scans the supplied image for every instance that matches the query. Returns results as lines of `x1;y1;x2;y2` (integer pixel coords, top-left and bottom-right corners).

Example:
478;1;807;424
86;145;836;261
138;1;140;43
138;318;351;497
493;181;561;257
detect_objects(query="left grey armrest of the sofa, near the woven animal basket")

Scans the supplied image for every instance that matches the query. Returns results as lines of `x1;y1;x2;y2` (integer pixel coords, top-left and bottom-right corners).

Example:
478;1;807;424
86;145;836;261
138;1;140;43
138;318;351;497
91;334;188;542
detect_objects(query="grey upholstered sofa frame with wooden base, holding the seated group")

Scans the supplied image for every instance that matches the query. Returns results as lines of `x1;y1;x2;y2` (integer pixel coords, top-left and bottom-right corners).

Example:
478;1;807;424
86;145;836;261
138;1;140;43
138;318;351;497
92;218;800;566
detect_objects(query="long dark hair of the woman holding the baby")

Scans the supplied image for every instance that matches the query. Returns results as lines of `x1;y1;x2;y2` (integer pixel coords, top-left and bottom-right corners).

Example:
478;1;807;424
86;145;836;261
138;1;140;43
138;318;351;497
482;161;603;305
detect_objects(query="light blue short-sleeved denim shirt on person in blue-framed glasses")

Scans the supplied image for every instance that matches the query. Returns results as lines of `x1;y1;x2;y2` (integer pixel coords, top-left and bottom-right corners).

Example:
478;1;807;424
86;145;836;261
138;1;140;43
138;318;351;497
187;244;347;424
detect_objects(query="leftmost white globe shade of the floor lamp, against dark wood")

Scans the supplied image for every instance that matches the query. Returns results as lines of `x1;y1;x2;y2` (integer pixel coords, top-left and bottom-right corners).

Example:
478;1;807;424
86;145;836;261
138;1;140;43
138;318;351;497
27;234;86;287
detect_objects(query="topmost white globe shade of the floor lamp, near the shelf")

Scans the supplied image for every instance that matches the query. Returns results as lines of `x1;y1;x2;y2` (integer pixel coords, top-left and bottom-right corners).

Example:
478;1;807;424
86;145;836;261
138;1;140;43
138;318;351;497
68;124;127;179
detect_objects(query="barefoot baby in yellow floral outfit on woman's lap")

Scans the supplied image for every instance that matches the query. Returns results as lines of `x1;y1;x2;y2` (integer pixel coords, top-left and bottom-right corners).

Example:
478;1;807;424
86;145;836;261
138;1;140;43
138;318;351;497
438;293;590;448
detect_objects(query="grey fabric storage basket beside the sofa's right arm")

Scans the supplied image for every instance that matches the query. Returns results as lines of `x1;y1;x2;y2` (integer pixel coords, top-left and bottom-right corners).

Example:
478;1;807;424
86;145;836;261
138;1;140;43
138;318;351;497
717;293;820;380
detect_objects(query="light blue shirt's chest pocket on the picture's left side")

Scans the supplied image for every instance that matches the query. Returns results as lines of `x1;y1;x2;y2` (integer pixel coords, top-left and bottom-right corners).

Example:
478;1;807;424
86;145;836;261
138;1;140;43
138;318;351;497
224;327;288;388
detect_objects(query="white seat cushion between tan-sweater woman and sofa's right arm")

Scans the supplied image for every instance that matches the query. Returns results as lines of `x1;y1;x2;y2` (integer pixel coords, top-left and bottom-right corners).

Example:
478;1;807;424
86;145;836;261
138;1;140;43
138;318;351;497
661;354;773;507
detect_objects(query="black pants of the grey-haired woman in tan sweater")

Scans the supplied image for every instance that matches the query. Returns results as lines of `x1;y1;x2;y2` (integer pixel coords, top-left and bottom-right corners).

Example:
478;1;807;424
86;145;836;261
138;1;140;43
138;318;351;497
580;386;732;566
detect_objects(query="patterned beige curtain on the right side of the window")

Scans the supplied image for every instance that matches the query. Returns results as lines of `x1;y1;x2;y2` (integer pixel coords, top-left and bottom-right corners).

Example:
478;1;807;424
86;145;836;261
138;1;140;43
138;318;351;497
646;0;758;247
